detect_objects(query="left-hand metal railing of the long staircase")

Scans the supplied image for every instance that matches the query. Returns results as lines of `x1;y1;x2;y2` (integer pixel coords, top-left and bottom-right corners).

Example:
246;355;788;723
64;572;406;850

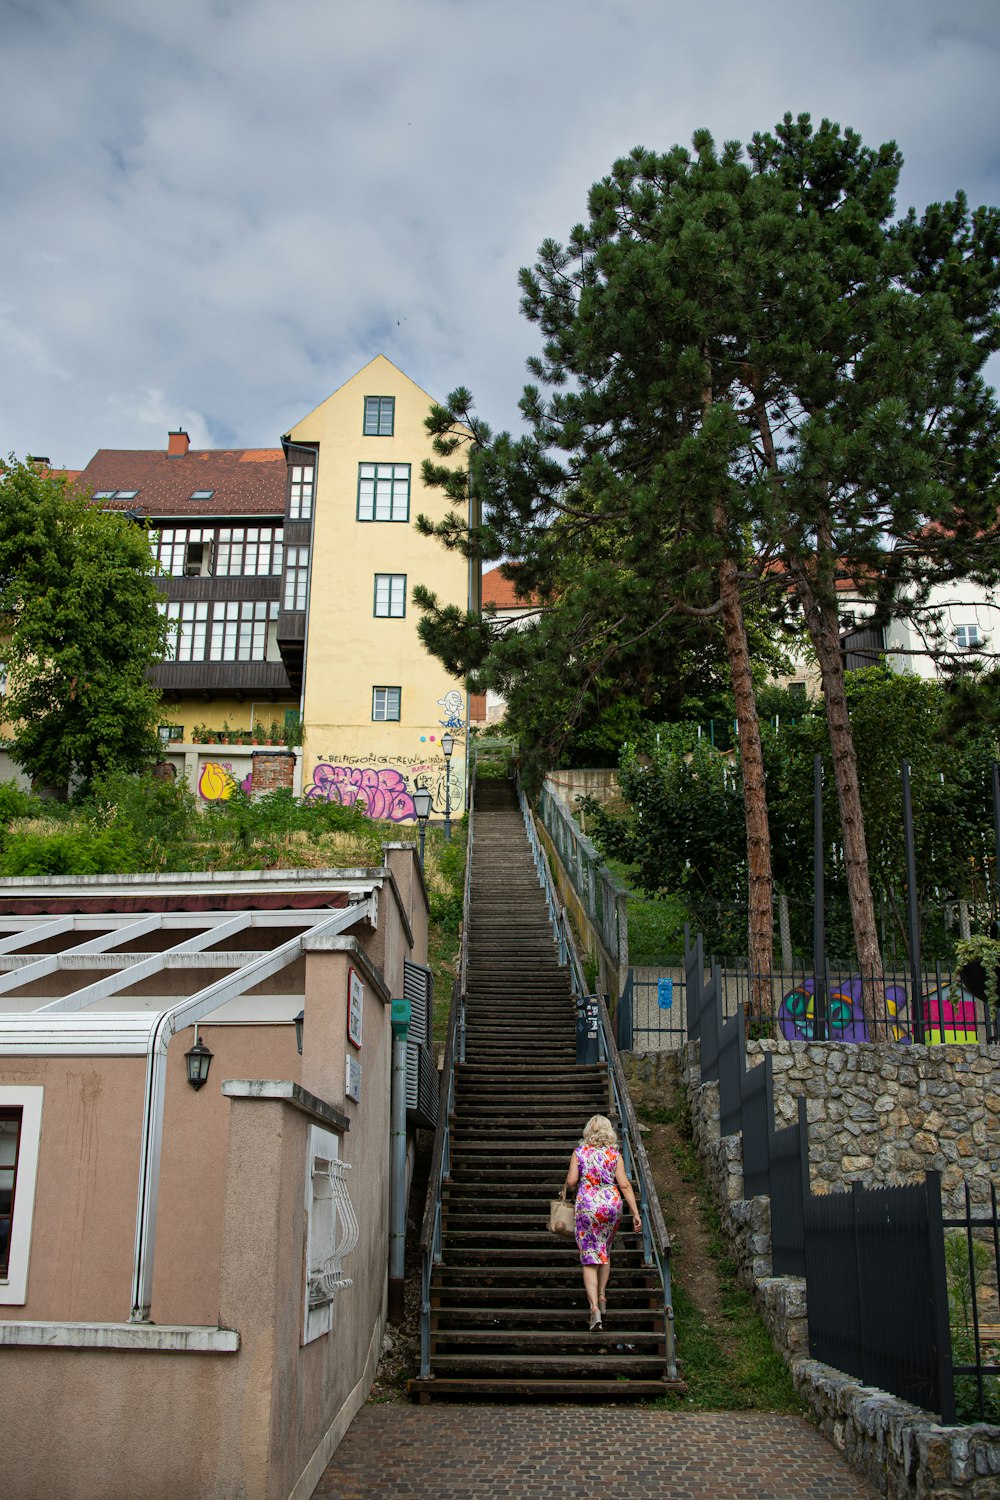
420;761;475;1380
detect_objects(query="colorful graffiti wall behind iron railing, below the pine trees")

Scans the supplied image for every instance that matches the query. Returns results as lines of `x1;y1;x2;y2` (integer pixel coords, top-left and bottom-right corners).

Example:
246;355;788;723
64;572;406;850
778;975;976;1043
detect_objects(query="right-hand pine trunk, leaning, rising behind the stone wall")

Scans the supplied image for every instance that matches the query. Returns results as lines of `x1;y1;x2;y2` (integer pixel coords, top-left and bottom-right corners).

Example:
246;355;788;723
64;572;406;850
802;584;885;1020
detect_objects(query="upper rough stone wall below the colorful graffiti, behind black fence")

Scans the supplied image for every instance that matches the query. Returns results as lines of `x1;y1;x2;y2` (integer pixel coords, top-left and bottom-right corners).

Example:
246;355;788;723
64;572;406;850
749;1041;1000;1214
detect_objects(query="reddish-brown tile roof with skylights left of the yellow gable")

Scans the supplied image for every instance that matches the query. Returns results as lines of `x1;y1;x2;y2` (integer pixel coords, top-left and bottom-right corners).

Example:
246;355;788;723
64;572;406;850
78;449;286;516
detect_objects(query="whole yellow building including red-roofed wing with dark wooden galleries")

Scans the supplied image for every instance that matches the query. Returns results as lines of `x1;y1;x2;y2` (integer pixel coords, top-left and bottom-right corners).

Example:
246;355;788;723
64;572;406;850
8;356;480;822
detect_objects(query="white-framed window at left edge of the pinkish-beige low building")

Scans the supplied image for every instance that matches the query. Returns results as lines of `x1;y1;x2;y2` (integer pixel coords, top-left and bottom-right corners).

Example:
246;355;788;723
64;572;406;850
0;1085;45;1305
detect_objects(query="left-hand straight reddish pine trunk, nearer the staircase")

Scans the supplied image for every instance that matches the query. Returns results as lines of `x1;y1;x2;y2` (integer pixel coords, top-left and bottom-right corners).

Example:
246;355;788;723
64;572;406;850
718;558;774;990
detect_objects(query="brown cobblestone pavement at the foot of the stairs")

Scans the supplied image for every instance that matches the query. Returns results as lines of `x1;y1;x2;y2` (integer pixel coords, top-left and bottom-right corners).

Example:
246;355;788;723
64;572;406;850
315;1403;876;1500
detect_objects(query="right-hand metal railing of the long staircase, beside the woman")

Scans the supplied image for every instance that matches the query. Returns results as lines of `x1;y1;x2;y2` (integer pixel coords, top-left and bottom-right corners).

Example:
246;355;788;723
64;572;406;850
517;785;678;1380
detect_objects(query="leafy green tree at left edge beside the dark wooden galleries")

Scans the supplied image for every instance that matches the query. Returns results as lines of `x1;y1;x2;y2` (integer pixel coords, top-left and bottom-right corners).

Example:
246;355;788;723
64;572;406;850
0;459;166;795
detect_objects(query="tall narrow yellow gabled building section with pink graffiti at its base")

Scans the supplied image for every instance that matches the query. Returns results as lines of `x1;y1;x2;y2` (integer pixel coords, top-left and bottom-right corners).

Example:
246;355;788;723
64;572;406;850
277;356;478;821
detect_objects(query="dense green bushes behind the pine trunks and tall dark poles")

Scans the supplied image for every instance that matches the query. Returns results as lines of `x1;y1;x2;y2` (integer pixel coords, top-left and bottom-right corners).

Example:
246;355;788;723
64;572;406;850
588;668;997;959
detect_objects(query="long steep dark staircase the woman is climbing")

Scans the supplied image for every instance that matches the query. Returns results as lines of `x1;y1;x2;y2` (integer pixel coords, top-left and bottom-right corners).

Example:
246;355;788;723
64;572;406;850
411;782;666;1401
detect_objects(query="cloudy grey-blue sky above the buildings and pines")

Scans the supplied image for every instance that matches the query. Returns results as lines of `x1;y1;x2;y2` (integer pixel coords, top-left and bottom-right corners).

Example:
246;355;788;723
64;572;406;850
0;0;1000;467
